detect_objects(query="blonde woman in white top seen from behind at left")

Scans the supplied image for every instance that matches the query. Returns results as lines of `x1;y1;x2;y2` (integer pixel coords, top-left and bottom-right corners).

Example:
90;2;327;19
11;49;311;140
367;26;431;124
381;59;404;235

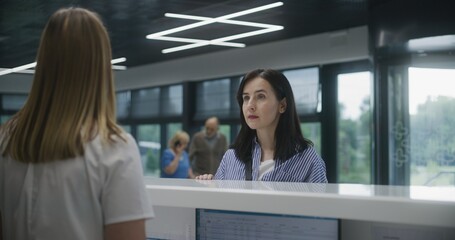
0;8;153;240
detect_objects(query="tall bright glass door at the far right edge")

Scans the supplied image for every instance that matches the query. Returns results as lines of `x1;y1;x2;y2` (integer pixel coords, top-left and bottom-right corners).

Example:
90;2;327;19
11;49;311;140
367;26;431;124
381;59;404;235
388;57;455;186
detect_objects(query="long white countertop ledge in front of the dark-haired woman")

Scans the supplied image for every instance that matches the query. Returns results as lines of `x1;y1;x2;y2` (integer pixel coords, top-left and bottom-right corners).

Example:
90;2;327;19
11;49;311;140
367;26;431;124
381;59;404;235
145;178;455;228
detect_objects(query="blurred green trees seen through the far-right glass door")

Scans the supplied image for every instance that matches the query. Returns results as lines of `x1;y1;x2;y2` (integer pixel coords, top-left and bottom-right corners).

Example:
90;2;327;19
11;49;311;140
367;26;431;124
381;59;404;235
410;96;455;186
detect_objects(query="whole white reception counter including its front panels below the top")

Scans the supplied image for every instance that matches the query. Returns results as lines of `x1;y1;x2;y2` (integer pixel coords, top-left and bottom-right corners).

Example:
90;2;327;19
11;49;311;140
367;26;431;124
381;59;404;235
145;178;455;240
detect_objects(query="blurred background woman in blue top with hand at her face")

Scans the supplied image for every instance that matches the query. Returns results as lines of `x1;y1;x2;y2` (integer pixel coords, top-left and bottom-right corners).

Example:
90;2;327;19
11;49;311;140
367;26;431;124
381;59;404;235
161;131;194;178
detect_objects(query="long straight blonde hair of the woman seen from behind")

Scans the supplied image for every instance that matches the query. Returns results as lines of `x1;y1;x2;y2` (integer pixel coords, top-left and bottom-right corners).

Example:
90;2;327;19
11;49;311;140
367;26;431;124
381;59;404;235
2;8;125;163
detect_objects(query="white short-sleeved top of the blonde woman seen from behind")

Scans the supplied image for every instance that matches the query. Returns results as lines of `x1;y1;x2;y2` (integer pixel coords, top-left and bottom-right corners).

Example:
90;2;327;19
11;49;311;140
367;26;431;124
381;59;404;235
0;134;154;240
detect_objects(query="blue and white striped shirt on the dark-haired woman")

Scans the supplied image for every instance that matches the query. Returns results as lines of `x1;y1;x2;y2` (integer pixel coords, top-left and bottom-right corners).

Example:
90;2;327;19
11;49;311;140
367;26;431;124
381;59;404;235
215;141;327;183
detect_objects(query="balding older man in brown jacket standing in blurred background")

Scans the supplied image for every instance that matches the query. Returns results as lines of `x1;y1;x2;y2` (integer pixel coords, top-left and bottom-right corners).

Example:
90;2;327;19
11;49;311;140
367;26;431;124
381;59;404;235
190;117;228;176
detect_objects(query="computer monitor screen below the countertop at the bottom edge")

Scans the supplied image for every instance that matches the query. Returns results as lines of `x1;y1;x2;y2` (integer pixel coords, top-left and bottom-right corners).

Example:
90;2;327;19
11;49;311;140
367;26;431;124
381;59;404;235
196;209;339;240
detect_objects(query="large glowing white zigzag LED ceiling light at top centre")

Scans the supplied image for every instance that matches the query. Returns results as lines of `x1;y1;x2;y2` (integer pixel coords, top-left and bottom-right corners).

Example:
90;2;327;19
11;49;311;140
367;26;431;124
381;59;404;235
146;2;284;54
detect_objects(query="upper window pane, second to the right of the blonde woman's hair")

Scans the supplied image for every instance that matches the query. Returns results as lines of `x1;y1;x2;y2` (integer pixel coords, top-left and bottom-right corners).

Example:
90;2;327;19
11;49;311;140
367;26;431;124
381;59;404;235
132;88;160;118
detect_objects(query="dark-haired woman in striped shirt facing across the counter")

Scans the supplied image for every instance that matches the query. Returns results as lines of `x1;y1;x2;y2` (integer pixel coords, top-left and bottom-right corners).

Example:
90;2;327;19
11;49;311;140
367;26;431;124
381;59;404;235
197;69;327;183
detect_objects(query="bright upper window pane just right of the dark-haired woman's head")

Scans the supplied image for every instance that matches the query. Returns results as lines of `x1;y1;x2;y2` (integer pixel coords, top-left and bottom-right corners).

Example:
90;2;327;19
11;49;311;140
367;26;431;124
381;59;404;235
283;68;321;115
